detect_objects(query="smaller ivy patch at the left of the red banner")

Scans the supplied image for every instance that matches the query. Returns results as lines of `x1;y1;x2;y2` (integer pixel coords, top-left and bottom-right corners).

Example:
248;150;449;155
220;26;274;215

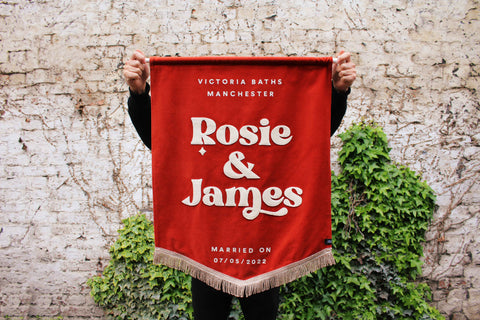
87;215;193;320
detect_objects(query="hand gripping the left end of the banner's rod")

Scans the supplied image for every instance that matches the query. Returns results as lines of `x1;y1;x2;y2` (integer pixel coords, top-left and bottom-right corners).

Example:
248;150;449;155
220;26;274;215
123;50;150;94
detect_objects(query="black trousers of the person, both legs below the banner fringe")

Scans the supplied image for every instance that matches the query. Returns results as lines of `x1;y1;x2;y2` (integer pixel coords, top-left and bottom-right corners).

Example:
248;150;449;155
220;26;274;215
192;278;280;320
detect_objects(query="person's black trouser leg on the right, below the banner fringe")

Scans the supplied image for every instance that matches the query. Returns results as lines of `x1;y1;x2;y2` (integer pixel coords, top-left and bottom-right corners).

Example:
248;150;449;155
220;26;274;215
239;287;280;320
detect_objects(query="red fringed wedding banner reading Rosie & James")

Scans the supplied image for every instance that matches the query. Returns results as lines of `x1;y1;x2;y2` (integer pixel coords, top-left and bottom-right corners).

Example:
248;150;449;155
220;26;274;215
150;57;334;297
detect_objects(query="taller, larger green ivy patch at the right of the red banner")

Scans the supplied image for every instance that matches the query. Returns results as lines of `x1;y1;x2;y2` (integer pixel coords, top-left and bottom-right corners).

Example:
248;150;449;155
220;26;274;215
281;123;443;319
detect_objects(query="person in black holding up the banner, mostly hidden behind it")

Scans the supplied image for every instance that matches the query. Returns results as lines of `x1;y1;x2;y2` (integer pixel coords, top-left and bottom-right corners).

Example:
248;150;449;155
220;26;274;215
123;50;356;320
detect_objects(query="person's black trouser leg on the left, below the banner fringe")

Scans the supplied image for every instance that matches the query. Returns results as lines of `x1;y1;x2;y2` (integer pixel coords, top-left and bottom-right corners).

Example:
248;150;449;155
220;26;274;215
192;278;232;320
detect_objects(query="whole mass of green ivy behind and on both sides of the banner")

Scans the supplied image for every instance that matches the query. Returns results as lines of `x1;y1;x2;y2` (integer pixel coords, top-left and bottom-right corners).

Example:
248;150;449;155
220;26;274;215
88;123;443;320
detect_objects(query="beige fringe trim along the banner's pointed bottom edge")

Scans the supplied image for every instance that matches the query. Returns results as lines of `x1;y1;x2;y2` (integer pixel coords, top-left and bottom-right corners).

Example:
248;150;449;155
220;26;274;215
153;247;335;297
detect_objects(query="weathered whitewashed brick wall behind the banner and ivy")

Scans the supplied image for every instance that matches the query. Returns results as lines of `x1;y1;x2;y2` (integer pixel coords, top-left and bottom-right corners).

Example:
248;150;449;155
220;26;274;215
0;0;480;320
